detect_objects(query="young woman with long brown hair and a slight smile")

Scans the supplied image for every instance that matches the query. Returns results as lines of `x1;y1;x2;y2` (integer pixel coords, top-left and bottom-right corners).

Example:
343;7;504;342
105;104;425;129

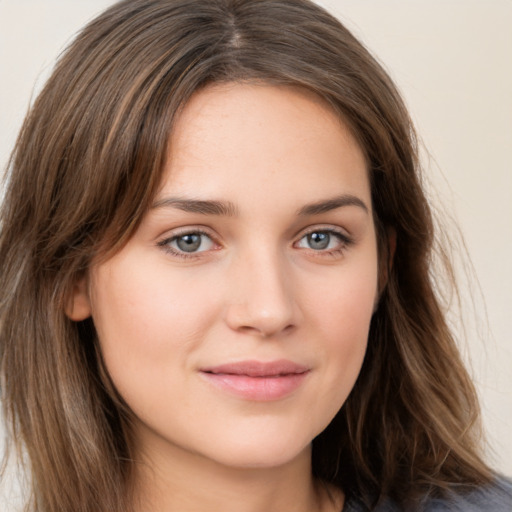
0;0;511;512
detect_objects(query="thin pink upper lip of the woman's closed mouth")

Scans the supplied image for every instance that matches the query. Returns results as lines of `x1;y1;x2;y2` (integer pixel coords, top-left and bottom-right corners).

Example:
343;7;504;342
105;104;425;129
201;359;310;377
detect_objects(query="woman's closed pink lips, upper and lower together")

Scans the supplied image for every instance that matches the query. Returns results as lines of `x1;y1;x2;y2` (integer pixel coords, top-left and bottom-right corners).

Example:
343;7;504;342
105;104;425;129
200;360;310;402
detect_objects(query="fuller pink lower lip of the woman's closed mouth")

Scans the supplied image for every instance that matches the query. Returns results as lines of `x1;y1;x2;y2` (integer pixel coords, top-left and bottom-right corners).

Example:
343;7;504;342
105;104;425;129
201;372;309;402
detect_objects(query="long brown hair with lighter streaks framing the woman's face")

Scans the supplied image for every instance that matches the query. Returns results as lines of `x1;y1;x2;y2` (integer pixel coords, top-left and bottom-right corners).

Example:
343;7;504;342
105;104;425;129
0;0;490;512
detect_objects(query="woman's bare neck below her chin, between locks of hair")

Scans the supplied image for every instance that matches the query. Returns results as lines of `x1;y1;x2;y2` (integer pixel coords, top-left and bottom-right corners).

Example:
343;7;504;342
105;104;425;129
130;436;343;512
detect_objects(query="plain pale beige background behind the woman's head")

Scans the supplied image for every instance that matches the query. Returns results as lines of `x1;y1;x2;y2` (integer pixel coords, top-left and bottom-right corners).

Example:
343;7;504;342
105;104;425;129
0;0;512;502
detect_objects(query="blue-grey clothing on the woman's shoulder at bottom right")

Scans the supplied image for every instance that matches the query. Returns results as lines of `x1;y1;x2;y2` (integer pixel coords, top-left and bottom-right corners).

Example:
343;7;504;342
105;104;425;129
343;477;512;512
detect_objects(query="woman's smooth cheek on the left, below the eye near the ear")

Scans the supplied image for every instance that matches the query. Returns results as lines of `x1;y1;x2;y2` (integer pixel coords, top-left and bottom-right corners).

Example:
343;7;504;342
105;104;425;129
91;258;222;401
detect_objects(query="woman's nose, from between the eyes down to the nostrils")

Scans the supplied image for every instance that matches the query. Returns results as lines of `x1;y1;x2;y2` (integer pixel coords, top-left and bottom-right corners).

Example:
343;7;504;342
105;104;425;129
226;248;299;337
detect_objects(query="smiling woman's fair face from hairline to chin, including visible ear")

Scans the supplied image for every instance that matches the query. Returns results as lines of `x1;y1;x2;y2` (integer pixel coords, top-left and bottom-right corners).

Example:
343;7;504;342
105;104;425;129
70;84;377;467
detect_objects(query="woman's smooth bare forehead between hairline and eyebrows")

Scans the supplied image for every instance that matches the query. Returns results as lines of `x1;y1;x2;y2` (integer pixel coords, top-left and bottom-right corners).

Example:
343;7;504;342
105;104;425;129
157;83;370;211
